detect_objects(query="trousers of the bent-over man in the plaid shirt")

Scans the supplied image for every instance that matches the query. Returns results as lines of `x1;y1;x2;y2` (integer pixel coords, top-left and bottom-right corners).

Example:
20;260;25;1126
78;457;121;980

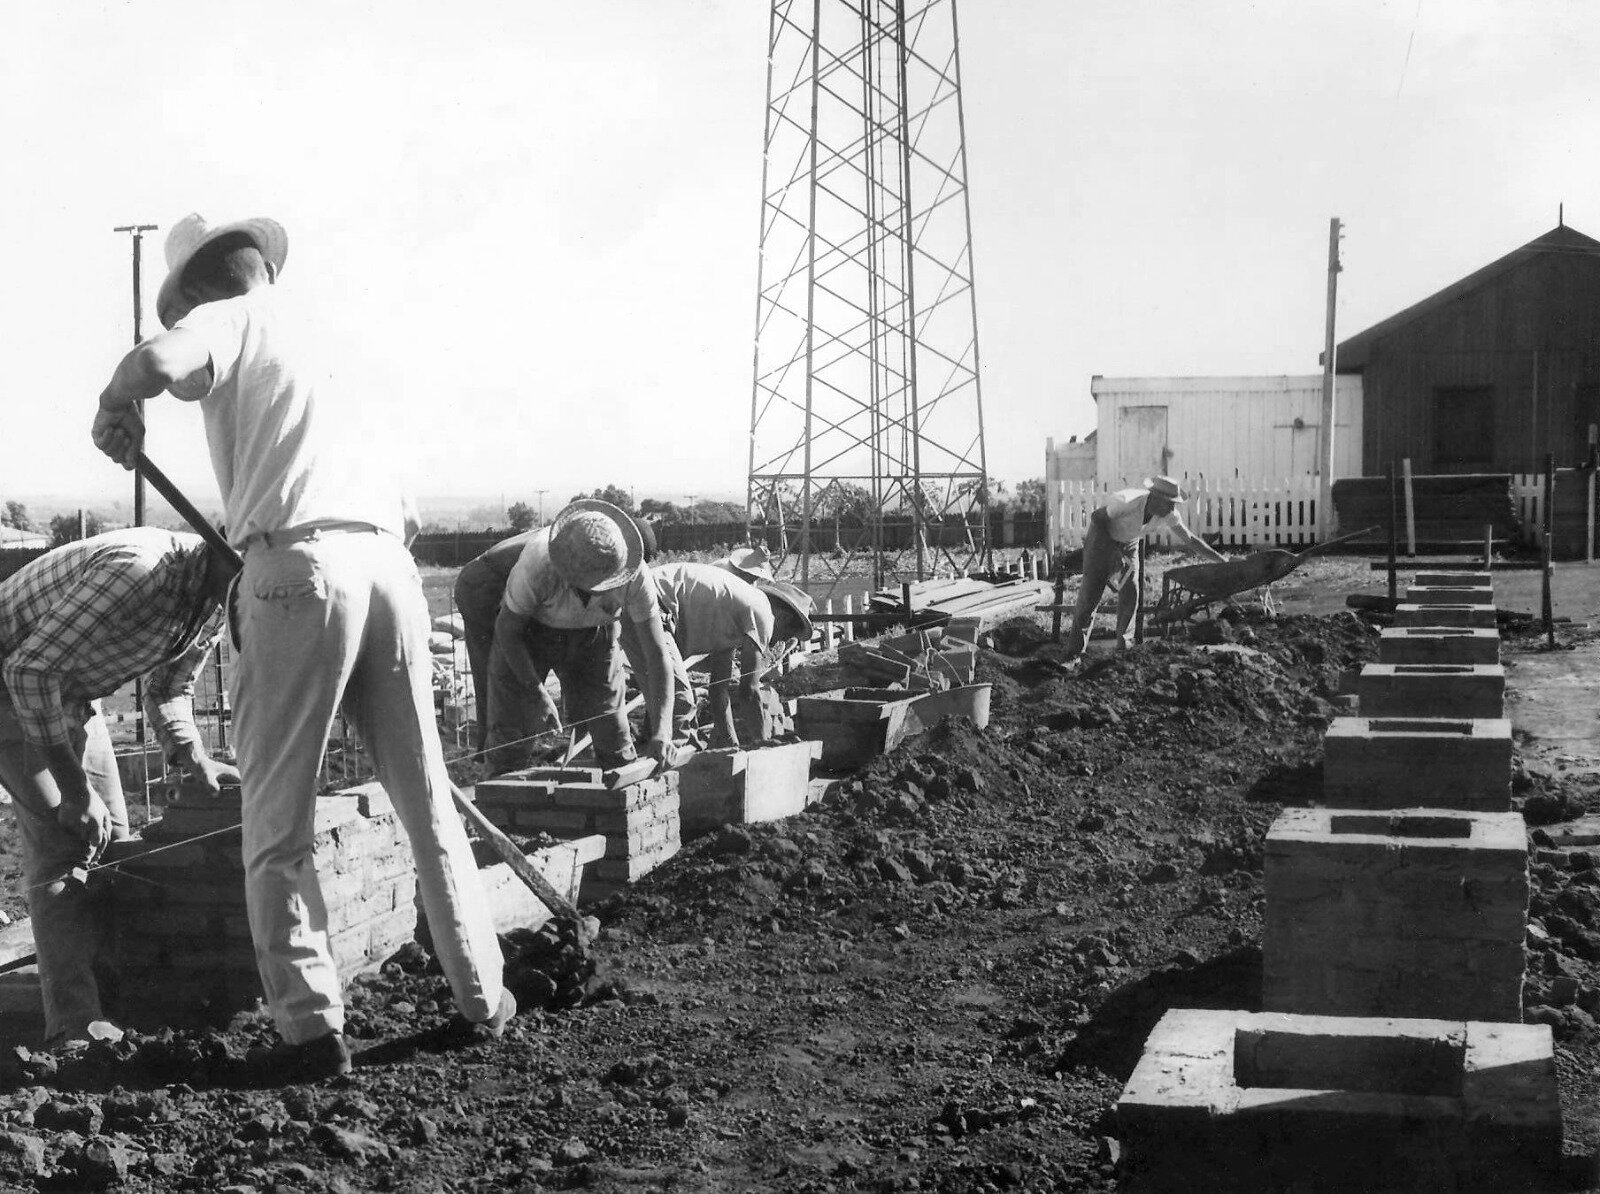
0;688;128;1040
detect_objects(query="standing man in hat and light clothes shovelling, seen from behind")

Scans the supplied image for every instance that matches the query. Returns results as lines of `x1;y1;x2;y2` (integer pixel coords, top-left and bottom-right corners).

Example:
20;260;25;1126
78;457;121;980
93;214;517;1080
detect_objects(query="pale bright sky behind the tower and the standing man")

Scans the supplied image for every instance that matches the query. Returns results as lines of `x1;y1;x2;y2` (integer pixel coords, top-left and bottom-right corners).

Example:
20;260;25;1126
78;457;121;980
0;0;1600;515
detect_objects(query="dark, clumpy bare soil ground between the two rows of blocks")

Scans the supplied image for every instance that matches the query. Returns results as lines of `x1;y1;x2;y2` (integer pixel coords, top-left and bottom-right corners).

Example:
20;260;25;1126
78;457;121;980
0;560;1600;1192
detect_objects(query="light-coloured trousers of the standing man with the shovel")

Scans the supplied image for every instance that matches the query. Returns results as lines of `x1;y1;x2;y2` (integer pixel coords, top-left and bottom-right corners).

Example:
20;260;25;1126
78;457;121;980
232;533;504;1044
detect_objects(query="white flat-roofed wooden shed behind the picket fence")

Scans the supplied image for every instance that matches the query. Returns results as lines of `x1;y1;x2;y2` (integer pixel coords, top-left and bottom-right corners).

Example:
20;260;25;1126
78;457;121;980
1090;373;1362;482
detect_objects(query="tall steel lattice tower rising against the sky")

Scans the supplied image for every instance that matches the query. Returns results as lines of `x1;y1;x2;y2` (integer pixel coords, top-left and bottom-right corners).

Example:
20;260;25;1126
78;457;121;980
747;0;989;584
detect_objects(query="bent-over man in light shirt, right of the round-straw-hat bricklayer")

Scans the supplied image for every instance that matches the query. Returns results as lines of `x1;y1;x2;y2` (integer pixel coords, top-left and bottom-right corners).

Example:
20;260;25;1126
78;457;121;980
622;563;811;747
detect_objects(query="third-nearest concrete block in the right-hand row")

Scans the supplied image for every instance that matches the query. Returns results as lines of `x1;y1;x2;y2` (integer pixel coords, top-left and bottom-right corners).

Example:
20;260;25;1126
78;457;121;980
1320;717;1510;813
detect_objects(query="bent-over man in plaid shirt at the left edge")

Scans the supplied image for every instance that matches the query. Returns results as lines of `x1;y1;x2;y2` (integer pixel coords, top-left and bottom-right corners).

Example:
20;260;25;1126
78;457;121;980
0;527;238;1045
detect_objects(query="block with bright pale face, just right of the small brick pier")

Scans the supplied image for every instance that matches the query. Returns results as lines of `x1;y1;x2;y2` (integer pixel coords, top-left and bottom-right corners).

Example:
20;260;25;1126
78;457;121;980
678;739;822;839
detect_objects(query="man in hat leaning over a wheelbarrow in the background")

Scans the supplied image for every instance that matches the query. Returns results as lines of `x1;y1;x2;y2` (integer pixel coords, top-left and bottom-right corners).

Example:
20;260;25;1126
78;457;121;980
1067;477;1227;656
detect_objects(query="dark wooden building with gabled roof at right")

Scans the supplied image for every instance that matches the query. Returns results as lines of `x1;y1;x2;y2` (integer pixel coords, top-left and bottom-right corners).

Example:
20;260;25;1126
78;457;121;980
1334;224;1600;475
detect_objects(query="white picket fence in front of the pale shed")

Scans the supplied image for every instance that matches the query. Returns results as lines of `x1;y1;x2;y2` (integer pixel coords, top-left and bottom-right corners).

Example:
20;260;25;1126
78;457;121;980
1045;475;1317;549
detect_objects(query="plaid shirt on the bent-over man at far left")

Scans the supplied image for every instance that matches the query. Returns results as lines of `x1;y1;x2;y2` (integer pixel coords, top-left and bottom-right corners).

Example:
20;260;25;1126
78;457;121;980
0;527;222;757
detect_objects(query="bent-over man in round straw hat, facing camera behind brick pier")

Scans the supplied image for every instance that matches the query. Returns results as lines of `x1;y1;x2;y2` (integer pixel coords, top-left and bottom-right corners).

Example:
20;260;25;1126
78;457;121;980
485;498;672;773
